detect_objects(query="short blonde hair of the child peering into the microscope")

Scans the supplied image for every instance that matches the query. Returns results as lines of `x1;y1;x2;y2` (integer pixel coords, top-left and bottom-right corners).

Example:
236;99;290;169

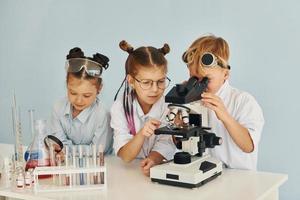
182;34;230;74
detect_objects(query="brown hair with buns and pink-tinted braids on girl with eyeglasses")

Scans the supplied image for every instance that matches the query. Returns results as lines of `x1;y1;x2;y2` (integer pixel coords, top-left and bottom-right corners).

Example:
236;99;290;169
115;40;170;135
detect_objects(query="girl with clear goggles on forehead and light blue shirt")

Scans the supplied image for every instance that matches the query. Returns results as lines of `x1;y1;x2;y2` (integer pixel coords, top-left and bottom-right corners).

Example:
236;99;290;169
51;47;112;153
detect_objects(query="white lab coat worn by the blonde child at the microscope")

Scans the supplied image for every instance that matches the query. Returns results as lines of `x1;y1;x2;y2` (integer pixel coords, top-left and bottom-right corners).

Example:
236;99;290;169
208;81;264;170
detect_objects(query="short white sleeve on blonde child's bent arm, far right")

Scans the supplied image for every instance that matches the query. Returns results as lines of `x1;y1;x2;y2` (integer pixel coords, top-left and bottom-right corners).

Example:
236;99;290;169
235;92;264;151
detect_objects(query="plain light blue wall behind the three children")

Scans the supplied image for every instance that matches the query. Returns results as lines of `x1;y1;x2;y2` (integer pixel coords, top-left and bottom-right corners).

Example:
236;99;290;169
0;0;300;200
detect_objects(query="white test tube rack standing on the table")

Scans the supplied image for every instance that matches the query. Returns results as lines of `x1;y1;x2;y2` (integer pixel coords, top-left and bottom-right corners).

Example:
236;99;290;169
33;165;107;193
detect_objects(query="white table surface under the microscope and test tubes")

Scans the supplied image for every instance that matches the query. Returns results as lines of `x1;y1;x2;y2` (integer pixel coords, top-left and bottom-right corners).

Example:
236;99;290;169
0;156;288;200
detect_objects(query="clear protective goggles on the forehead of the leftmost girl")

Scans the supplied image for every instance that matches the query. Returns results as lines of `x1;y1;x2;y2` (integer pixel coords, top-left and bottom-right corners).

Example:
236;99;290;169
65;58;107;78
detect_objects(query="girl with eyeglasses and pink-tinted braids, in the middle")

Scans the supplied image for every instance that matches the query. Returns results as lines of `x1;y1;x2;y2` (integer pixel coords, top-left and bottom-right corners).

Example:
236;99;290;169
111;41;176;176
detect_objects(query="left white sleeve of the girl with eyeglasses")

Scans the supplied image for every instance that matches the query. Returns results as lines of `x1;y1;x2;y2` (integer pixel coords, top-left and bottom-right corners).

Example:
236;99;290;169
110;99;133;155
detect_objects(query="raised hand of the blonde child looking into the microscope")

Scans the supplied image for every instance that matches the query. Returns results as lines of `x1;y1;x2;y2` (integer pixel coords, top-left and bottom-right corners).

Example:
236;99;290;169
201;92;229;121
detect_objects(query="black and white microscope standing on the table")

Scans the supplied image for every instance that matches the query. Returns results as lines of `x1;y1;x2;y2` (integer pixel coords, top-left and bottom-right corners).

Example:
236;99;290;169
150;77;222;188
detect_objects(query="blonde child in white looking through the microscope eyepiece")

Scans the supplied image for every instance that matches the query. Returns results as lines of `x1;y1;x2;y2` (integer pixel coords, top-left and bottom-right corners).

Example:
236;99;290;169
182;35;264;170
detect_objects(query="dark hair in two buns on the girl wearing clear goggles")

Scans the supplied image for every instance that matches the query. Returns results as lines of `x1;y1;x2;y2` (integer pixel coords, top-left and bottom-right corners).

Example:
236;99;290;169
66;47;109;88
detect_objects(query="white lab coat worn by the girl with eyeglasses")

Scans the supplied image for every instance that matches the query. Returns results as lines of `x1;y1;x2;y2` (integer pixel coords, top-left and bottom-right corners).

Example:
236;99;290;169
111;96;176;160
